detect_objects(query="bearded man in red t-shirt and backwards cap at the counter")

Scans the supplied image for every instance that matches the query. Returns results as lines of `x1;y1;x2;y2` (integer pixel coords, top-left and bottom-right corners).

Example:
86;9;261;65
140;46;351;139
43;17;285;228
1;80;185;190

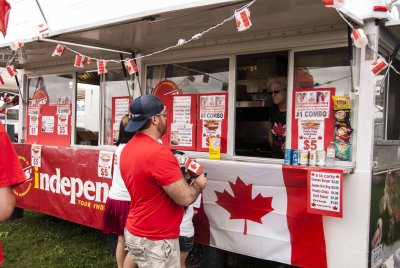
120;95;207;268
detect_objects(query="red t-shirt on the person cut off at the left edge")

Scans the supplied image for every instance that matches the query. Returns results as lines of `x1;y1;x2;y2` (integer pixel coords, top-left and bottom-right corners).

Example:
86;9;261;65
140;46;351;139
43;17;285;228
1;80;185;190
0;122;25;264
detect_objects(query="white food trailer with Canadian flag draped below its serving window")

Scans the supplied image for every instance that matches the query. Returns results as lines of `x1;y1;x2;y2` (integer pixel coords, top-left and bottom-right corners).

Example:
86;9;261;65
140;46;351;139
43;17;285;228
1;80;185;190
0;0;400;267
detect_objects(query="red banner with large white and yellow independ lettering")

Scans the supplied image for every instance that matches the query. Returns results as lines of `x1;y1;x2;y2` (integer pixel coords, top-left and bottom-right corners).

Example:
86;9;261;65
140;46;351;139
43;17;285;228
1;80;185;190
13;144;111;229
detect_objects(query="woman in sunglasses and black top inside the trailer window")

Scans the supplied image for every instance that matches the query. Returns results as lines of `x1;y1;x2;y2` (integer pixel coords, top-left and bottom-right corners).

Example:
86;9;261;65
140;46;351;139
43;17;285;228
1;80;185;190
267;77;287;158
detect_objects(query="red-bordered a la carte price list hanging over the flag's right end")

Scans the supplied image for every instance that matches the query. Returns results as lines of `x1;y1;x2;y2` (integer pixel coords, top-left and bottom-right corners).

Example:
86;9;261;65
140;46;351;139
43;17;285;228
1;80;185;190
307;168;343;218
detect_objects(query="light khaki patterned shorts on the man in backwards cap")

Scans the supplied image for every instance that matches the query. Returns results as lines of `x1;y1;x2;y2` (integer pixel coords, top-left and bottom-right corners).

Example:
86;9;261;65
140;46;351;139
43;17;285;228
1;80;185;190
125;229;180;268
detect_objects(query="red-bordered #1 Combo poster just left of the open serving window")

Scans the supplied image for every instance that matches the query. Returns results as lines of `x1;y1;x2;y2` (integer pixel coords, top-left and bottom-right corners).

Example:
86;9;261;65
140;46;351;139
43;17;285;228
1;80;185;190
196;93;228;153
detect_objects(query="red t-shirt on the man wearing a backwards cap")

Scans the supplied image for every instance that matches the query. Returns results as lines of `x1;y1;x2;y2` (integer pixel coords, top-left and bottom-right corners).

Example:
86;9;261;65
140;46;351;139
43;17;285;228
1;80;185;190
120;133;183;240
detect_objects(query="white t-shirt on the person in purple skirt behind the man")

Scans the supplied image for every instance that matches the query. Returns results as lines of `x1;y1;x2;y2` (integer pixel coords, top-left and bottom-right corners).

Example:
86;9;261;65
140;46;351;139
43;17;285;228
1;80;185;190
108;143;131;201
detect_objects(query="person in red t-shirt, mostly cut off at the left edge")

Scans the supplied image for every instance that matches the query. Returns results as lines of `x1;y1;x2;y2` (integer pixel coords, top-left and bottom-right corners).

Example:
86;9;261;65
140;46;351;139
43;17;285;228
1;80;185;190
0;122;25;265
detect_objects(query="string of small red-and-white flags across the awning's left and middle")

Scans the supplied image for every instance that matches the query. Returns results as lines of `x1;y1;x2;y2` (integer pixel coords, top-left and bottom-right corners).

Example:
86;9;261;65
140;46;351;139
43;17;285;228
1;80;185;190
0;0;256;77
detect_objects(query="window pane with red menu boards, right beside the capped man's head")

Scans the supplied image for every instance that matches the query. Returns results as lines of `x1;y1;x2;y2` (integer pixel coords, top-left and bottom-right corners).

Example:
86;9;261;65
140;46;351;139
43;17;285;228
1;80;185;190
146;59;229;153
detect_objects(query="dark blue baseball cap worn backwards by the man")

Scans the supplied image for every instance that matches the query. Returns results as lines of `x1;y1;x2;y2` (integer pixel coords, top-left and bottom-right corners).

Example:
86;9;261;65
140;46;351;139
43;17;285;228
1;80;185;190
125;95;164;132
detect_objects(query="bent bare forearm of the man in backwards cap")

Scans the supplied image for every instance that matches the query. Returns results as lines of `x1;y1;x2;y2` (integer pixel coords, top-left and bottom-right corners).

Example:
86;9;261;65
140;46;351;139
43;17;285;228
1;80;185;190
163;173;207;207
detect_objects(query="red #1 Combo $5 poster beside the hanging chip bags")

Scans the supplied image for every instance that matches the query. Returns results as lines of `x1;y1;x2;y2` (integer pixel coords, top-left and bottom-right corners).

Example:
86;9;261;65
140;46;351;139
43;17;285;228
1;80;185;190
292;88;335;151
